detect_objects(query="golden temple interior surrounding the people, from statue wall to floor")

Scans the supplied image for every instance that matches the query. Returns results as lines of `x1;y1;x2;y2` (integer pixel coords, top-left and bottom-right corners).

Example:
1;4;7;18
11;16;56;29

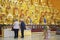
0;0;60;40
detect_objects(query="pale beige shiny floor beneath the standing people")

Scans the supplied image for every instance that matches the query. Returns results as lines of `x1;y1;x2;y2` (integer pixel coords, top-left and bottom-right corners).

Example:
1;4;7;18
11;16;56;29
0;33;60;40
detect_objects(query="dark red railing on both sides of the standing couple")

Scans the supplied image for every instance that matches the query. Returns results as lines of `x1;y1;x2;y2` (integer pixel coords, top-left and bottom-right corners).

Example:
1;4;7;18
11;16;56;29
0;24;60;31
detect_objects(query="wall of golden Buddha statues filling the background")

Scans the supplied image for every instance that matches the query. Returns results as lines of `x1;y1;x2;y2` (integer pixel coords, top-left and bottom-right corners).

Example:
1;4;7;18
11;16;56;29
0;0;60;24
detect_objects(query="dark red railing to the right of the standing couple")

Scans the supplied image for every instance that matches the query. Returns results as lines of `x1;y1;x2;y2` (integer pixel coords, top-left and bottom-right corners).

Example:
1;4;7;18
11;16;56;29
26;25;60;32
